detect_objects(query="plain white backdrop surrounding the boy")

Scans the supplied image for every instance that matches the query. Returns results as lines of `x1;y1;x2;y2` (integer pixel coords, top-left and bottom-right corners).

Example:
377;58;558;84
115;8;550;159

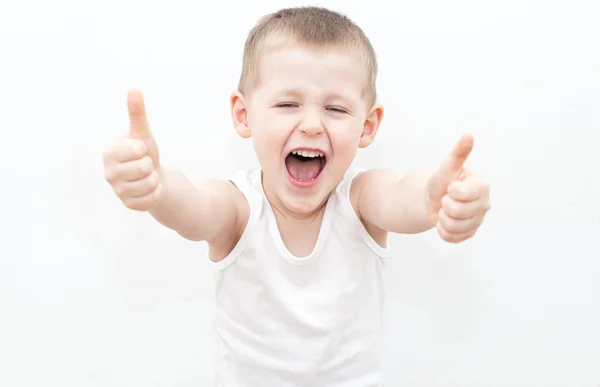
0;0;600;387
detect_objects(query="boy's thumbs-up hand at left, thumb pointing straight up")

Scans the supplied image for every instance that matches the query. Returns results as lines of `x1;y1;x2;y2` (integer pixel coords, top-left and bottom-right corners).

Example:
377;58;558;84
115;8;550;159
104;90;162;211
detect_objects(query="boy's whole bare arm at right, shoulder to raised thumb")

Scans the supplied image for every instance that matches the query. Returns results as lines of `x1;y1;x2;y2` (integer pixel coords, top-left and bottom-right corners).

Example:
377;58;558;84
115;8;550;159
351;135;490;243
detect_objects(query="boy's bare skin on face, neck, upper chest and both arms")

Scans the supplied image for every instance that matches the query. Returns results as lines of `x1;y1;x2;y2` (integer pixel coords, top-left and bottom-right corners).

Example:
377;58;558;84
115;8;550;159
104;41;490;261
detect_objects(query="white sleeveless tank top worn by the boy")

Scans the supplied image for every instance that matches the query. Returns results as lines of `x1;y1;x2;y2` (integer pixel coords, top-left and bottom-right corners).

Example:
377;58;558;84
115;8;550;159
214;169;387;387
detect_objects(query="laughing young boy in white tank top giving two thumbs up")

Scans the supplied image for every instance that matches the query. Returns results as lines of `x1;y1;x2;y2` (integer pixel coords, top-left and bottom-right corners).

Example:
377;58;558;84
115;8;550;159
104;7;490;387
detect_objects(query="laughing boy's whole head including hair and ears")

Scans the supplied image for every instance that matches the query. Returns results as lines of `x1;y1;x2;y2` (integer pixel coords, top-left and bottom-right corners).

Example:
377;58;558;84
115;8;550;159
231;7;383;212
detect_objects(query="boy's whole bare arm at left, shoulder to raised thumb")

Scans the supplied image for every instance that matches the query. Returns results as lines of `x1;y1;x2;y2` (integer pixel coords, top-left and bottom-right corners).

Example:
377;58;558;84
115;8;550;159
104;90;249;255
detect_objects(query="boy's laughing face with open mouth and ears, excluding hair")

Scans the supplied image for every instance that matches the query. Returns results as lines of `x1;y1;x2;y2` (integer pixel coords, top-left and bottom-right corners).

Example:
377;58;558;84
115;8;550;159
231;45;383;214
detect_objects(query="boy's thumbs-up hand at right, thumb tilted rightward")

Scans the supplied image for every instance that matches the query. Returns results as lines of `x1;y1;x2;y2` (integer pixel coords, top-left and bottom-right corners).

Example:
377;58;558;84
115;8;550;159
427;135;490;243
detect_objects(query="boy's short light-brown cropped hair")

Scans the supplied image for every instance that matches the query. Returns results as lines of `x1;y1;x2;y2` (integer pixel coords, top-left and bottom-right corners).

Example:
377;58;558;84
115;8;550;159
238;7;377;103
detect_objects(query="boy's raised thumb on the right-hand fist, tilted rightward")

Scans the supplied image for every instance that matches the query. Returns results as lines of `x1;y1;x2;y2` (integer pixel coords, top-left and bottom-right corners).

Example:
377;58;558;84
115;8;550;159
429;134;473;201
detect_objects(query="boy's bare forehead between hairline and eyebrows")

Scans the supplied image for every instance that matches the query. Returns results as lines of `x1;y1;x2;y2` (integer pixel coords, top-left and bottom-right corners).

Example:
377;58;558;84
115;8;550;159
256;42;368;99
